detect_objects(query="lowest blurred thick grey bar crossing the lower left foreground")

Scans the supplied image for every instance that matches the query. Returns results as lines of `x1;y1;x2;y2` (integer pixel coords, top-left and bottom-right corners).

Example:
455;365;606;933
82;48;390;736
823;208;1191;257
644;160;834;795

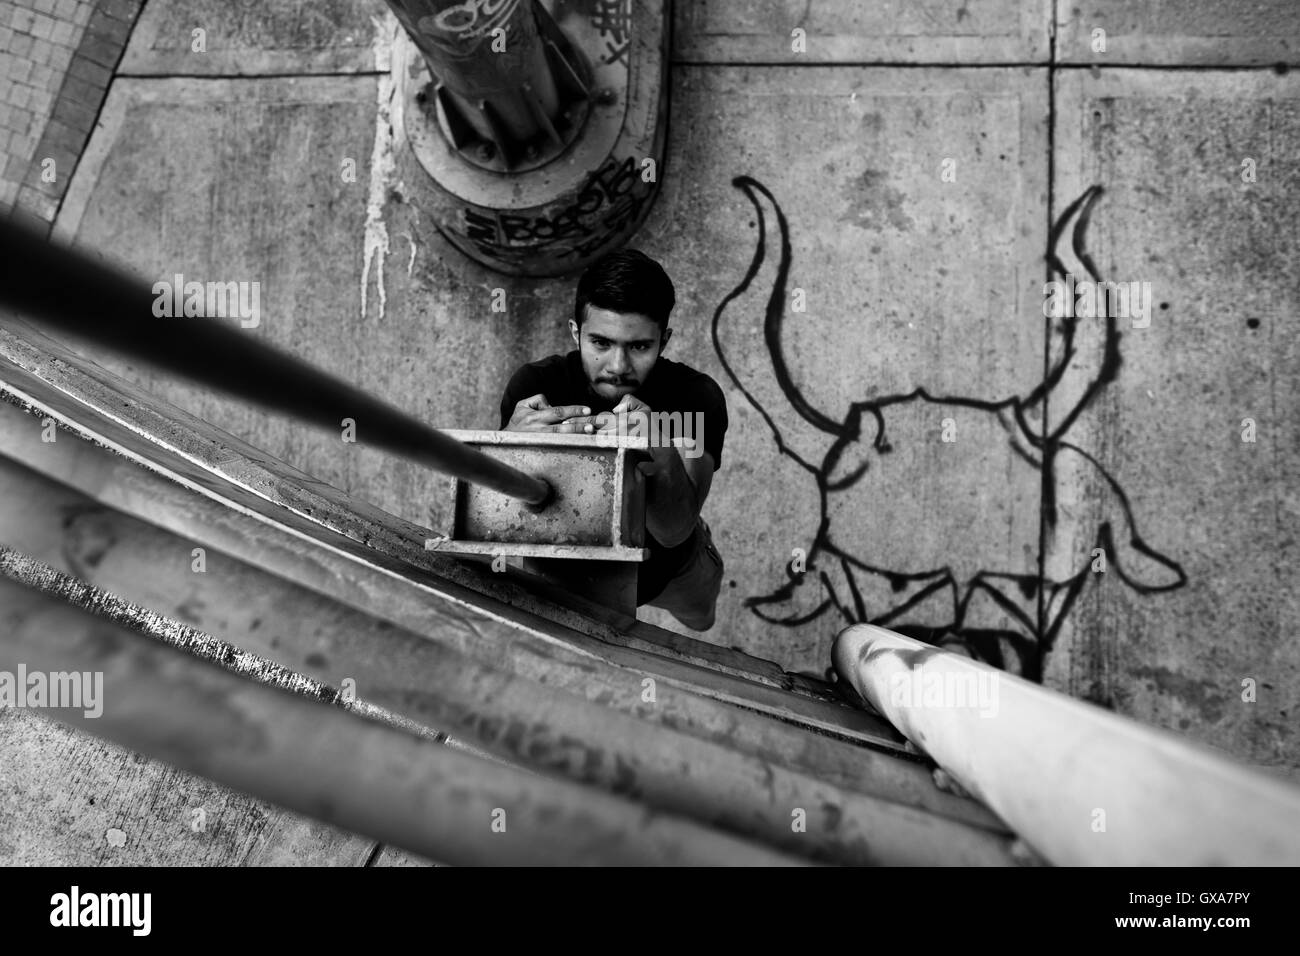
0;578;793;866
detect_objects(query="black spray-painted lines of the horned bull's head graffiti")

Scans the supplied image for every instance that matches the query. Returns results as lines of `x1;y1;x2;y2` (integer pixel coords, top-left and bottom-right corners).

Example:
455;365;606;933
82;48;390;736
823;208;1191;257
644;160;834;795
711;176;1187;679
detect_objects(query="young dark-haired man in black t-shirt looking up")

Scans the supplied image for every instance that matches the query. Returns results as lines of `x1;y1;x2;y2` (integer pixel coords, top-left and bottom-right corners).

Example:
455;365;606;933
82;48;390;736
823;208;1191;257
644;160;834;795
501;250;727;631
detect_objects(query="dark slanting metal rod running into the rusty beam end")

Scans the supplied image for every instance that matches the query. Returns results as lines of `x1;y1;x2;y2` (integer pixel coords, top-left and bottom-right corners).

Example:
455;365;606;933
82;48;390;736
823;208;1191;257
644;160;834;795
0;219;554;509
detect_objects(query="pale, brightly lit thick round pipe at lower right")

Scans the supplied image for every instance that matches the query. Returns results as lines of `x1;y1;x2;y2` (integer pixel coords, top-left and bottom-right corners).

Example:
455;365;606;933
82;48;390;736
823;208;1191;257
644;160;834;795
833;624;1300;866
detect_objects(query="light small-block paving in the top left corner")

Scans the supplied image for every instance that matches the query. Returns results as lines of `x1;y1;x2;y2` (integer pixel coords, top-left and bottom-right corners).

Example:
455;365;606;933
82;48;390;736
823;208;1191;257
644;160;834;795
0;0;142;222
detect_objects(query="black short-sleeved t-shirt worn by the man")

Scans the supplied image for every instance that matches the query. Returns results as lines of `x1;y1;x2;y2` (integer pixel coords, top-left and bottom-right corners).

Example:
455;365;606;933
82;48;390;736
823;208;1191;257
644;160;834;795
501;349;727;605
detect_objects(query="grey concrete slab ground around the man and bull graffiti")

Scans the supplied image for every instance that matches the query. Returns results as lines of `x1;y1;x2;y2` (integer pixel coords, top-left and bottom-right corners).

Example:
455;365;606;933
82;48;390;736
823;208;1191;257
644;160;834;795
2;0;1300;868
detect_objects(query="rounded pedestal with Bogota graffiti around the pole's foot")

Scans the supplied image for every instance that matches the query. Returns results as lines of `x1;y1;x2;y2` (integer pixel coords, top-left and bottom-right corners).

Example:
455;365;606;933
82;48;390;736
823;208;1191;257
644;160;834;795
393;0;671;277
